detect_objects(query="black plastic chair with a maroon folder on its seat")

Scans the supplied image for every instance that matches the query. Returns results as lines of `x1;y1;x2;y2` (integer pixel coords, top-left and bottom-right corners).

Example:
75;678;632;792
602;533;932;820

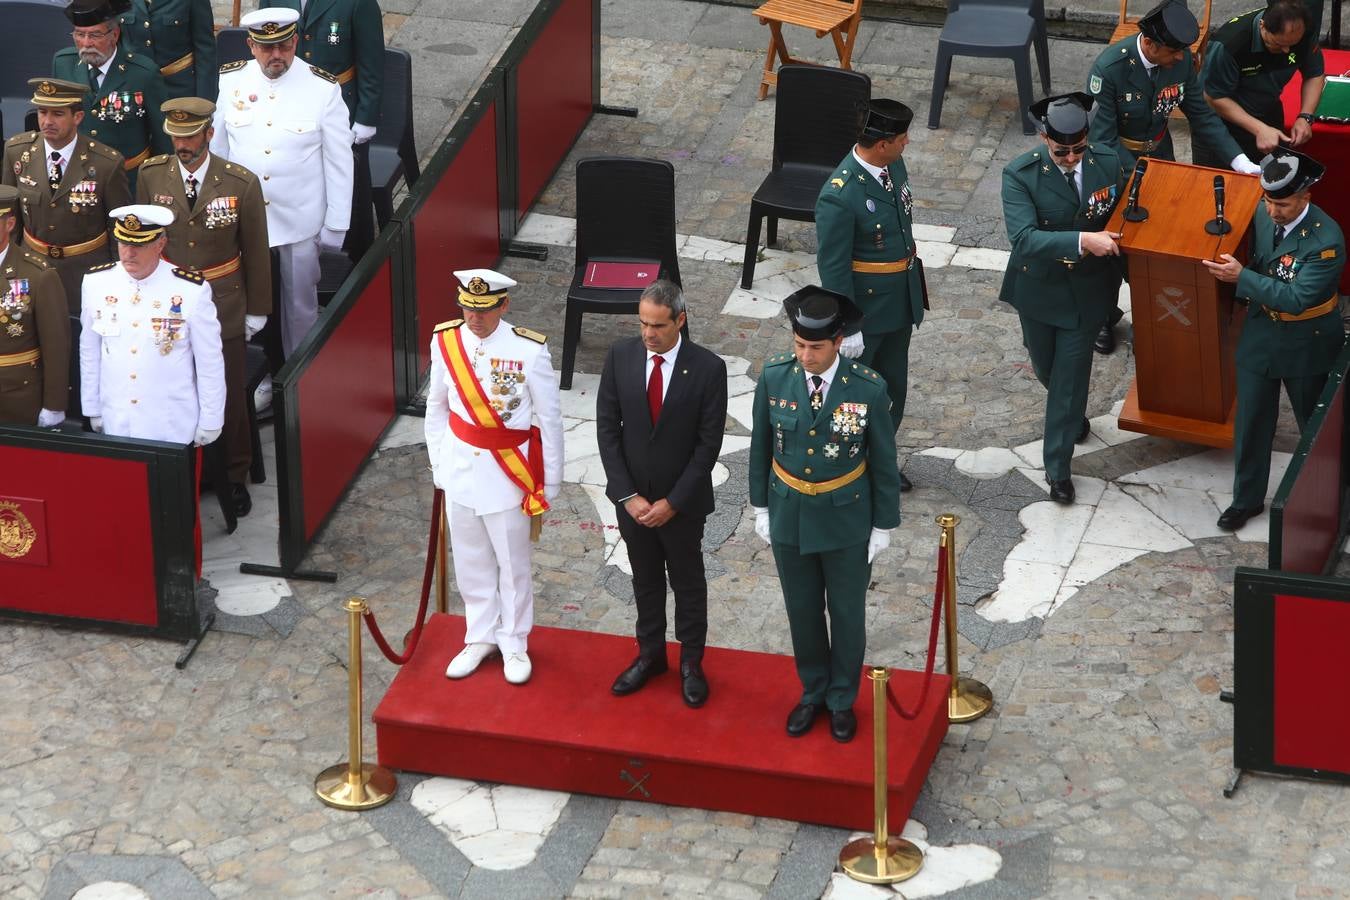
560;157;689;390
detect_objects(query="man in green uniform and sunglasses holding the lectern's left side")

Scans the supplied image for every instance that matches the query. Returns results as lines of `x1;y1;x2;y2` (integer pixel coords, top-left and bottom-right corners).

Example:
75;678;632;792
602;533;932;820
999;93;1130;503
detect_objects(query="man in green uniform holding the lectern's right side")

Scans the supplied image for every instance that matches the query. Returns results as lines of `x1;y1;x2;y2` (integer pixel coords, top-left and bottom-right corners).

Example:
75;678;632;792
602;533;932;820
1203;150;1346;532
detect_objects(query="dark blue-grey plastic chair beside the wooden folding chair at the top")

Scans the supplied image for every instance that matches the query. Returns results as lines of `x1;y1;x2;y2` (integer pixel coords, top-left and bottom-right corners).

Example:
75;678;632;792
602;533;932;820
929;0;1050;135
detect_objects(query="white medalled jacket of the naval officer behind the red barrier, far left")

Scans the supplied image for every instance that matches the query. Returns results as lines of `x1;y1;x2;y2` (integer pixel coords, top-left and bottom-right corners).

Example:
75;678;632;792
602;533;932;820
80;260;225;444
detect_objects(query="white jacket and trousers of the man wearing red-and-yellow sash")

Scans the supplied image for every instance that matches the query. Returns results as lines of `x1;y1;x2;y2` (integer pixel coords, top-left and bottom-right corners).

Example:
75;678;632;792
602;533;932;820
425;321;563;653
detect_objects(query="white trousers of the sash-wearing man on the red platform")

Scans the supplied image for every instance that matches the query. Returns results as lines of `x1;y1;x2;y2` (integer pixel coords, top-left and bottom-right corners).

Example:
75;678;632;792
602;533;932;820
450;502;535;653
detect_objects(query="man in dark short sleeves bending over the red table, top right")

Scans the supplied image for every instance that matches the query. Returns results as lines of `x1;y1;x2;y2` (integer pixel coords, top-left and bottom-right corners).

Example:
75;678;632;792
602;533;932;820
1192;0;1327;166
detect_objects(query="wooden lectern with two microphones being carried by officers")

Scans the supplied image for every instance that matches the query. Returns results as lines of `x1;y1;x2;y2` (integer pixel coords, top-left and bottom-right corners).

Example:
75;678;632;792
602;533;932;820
1107;159;1261;447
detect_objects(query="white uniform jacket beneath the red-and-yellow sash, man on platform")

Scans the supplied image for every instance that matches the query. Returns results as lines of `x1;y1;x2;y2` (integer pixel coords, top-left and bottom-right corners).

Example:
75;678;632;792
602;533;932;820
425;321;563;515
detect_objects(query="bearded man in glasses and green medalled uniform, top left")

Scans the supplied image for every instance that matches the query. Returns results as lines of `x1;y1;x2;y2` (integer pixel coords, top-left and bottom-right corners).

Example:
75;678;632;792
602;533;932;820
51;0;173;192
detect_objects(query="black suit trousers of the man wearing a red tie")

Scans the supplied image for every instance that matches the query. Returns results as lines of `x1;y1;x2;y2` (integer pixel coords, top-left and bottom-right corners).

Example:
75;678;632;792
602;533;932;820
616;503;707;663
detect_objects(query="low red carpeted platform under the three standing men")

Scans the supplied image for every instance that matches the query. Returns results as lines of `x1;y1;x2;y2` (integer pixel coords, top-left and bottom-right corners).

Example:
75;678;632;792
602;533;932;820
374;615;948;831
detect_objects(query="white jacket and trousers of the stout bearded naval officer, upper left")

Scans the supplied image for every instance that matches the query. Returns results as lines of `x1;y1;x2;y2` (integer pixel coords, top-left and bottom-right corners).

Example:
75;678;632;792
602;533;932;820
211;59;354;355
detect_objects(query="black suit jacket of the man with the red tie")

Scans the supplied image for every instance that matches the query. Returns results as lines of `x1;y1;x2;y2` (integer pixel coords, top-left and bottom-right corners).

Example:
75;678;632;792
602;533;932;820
595;337;726;515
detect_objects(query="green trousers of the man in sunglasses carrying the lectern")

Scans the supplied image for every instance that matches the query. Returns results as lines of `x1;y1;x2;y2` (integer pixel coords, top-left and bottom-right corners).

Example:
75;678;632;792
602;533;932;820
1018;314;1098;482
